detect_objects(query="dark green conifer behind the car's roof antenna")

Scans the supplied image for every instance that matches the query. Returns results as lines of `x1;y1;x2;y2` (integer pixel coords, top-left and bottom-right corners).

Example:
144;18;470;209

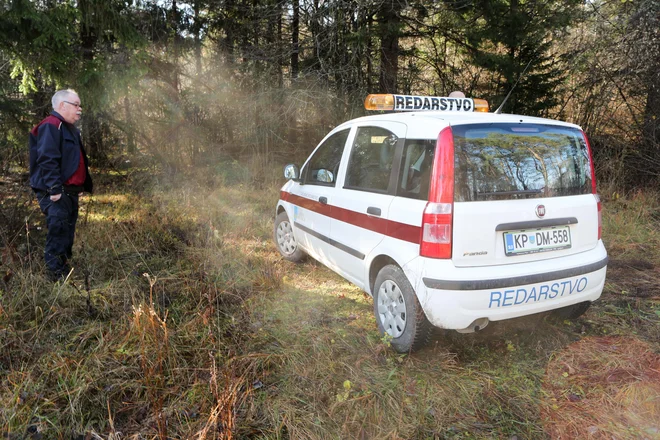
445;0;581;116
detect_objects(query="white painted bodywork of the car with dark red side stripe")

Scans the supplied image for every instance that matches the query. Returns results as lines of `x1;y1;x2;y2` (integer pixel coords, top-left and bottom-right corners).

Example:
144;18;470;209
277;112;607;330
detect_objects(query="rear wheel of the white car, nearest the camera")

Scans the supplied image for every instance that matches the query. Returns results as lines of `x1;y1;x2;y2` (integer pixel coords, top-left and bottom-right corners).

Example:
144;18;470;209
373;264;433;353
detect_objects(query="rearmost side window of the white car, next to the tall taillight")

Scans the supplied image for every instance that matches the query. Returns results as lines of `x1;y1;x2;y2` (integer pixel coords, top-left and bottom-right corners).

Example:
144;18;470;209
397;139;436;200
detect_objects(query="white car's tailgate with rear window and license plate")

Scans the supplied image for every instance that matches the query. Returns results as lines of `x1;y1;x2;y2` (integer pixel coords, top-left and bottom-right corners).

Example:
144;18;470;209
452;123;598;266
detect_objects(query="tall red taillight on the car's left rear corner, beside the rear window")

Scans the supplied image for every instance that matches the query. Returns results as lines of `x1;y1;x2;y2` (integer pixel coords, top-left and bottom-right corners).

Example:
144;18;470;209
419;127;454;258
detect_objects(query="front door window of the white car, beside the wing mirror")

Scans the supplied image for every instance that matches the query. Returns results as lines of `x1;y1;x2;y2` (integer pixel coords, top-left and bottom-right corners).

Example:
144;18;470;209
303;129;350;186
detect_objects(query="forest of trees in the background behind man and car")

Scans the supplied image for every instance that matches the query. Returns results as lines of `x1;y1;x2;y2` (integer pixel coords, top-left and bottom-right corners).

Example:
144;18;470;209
0;0;660;186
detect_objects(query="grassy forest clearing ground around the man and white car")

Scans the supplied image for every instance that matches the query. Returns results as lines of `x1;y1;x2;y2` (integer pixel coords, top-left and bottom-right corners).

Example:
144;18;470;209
0;167;660;439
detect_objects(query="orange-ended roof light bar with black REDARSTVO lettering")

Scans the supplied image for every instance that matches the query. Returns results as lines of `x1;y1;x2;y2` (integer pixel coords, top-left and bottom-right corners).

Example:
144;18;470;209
364;94;489;112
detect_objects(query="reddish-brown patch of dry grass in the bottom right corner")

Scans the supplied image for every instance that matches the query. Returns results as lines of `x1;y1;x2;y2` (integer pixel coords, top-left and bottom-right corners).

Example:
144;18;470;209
542;337;660;439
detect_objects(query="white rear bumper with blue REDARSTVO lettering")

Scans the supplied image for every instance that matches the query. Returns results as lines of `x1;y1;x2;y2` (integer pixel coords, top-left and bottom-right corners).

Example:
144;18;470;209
404;241;607;329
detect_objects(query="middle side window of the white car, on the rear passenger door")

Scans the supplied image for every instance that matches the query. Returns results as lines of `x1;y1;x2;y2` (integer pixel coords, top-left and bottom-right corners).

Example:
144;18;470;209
346;127;399;192
